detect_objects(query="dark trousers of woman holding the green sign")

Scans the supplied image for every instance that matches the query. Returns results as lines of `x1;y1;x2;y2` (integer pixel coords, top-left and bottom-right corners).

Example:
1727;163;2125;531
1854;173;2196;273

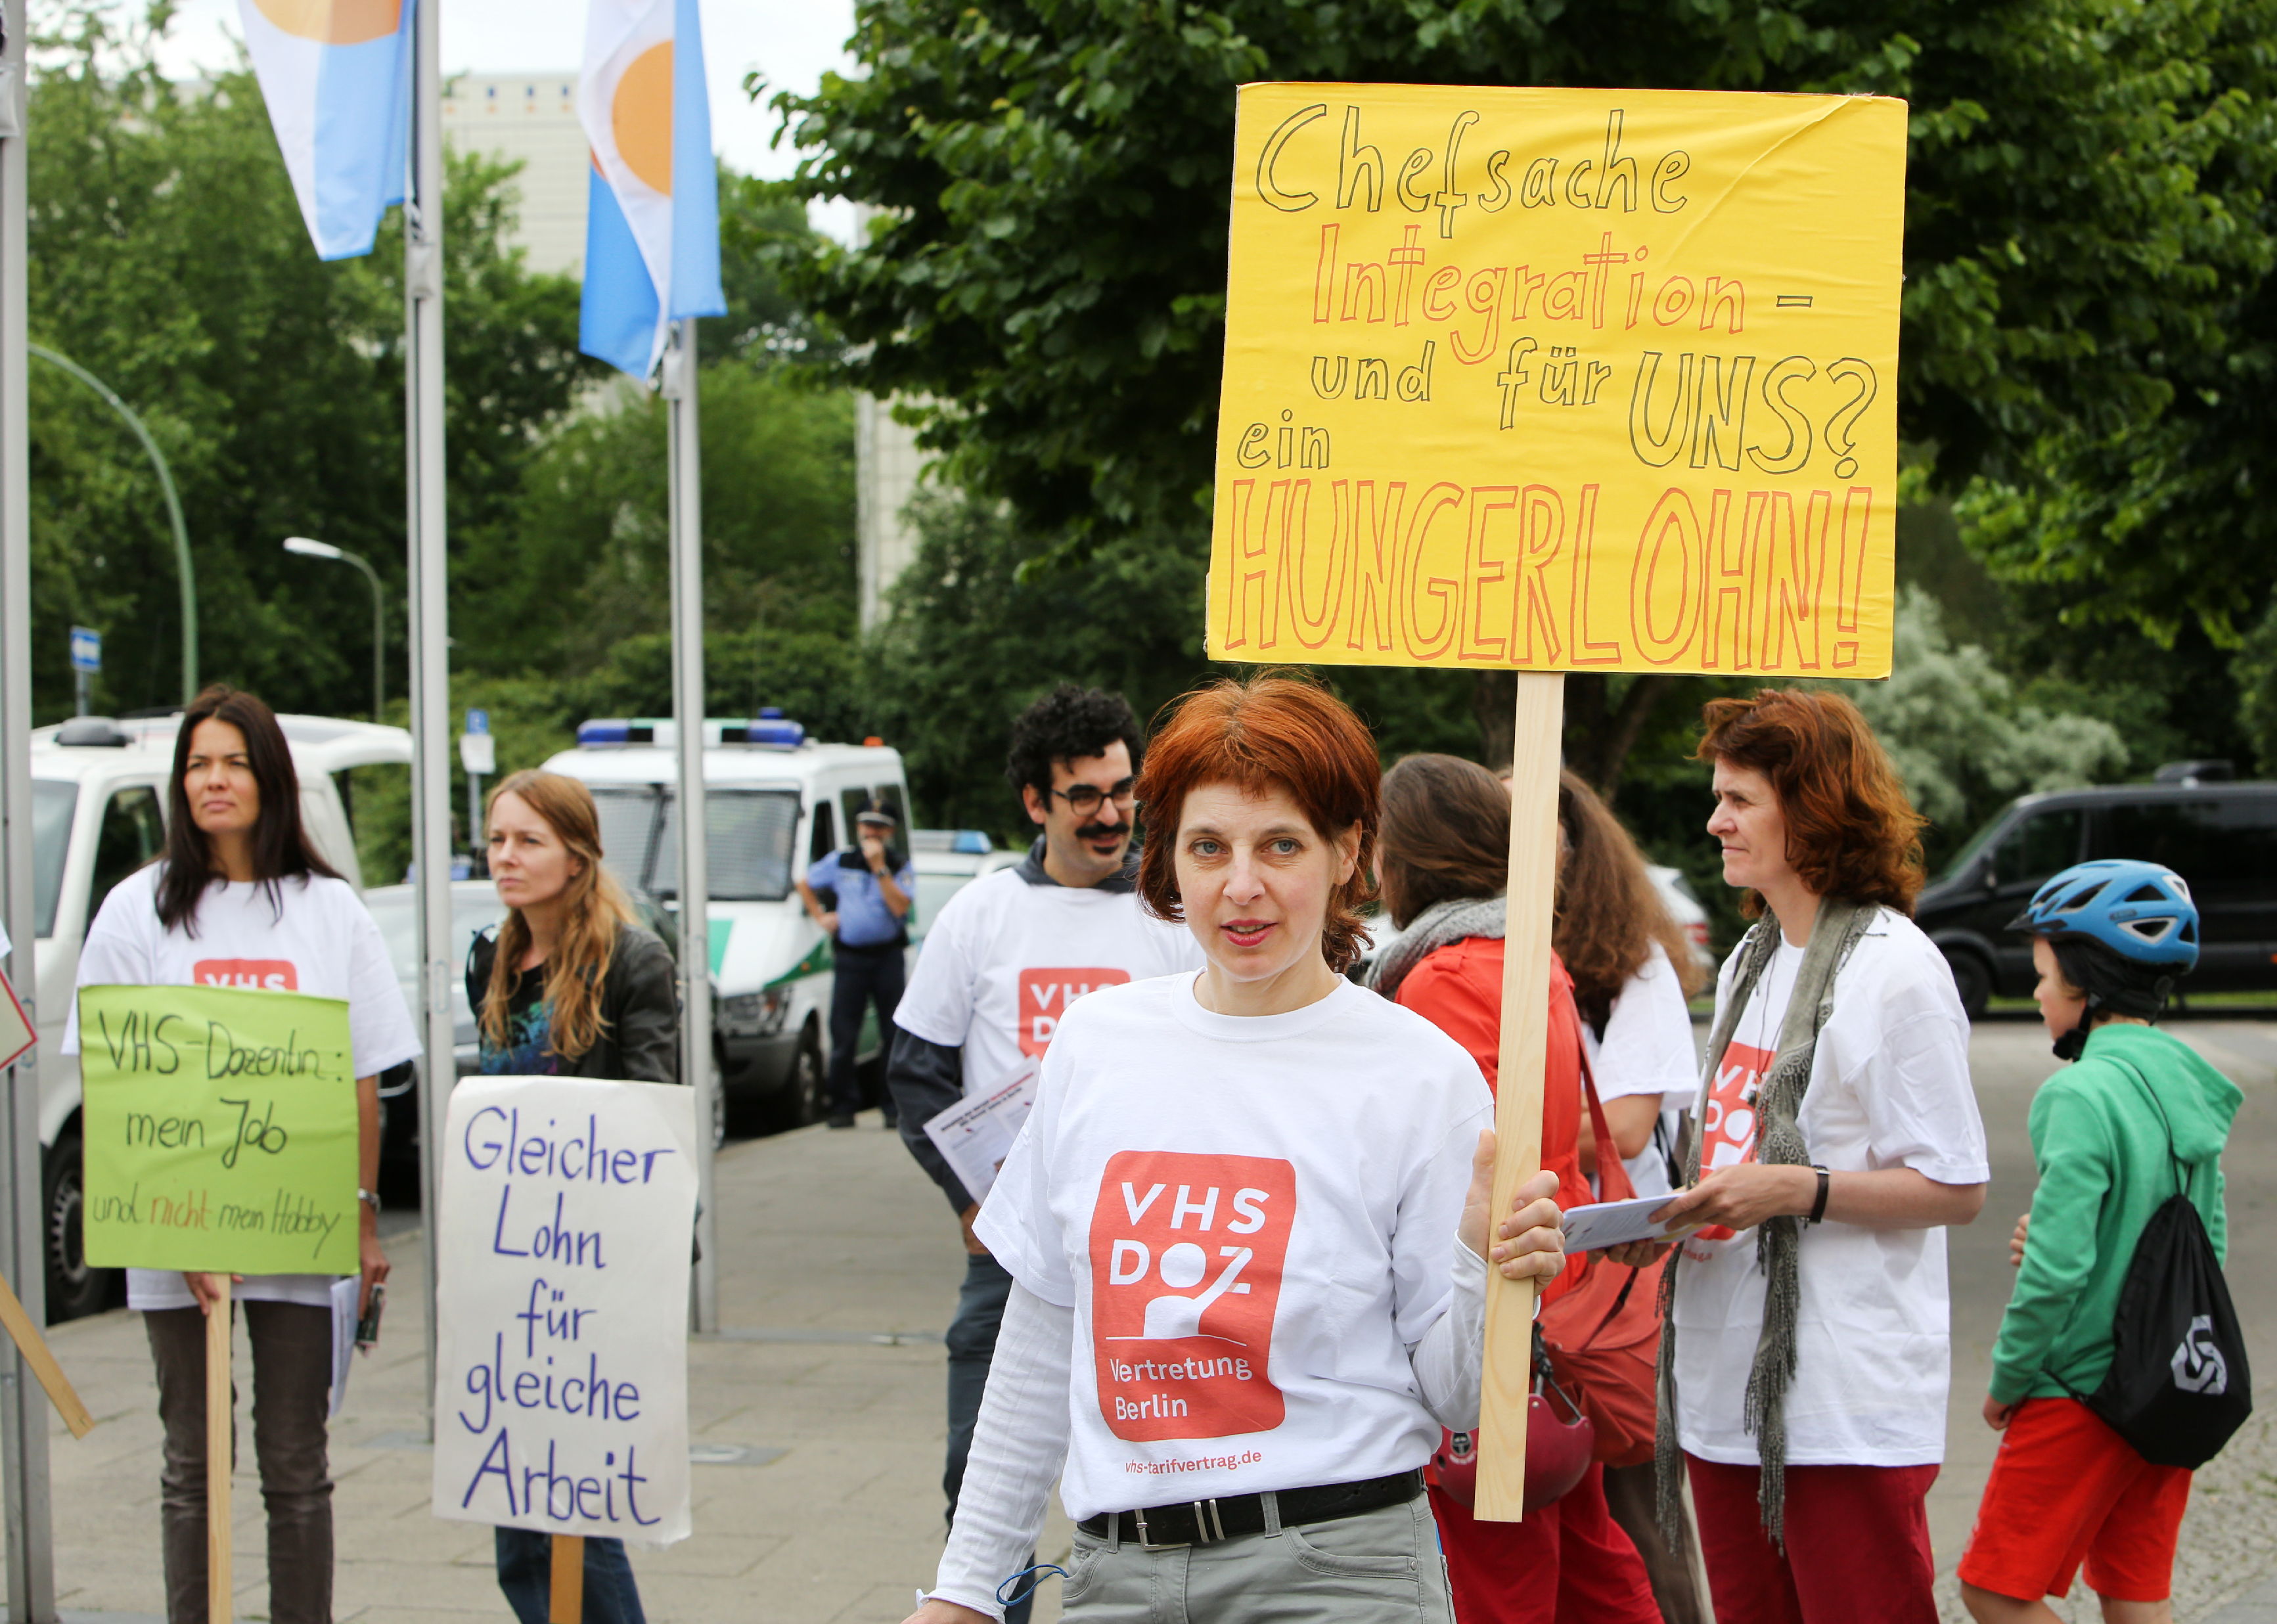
143;1303;332;1624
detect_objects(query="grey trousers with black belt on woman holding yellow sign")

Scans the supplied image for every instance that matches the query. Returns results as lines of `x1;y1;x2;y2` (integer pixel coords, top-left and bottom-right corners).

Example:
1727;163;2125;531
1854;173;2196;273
1061;1494;1455;1624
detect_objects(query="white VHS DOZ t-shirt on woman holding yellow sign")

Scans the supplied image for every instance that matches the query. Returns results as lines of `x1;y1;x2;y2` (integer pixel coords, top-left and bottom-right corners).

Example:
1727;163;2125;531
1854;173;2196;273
974;975;1494;1520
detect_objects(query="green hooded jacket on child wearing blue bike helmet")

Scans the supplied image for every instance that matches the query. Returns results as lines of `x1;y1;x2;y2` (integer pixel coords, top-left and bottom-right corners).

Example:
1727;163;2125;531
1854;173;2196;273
1993;1020;2245;1403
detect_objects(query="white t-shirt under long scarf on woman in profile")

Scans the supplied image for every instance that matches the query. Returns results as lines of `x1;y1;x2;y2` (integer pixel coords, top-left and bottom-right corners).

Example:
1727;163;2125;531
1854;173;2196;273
1674;909;1993;1467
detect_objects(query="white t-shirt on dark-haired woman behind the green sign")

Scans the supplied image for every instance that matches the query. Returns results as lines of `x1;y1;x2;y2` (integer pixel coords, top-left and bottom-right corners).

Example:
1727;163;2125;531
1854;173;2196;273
64;863;419;1310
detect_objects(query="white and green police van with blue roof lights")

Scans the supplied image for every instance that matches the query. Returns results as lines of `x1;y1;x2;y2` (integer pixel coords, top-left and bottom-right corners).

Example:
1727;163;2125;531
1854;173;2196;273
547;708;918;1125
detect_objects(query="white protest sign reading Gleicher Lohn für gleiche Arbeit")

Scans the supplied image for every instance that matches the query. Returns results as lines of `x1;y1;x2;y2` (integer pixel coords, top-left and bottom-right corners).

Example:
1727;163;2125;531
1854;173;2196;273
435;1077;697;1545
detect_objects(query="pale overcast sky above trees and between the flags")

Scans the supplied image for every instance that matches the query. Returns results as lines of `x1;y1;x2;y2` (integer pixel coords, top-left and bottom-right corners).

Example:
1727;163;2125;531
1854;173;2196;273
147;0;854;235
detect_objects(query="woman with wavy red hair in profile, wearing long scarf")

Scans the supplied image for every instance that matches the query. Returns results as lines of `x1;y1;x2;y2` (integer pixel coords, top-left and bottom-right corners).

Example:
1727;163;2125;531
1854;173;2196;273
1621;688;1990;1624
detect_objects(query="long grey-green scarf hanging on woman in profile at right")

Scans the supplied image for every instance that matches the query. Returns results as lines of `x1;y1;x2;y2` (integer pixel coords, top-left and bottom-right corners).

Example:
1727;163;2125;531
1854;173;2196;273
1653;897;1881;1551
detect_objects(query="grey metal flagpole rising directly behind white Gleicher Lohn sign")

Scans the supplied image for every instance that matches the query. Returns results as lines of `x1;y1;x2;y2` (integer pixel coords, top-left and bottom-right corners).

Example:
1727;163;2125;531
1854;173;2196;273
665;319;719;1330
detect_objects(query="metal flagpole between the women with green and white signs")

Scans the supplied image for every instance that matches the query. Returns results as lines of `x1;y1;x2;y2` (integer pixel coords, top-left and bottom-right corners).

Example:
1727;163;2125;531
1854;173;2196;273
403;0;458;1439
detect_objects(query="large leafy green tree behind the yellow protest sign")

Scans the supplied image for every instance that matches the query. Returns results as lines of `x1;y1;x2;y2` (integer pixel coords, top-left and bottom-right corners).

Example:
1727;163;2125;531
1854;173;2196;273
777;0;2268;784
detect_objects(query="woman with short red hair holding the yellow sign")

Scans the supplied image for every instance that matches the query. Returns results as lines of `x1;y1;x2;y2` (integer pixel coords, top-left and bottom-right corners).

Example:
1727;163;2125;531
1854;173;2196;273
915;677;1564;1624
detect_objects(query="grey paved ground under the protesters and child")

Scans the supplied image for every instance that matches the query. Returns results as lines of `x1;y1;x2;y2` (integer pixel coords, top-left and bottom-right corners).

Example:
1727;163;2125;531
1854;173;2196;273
0;1020;2277;1624
